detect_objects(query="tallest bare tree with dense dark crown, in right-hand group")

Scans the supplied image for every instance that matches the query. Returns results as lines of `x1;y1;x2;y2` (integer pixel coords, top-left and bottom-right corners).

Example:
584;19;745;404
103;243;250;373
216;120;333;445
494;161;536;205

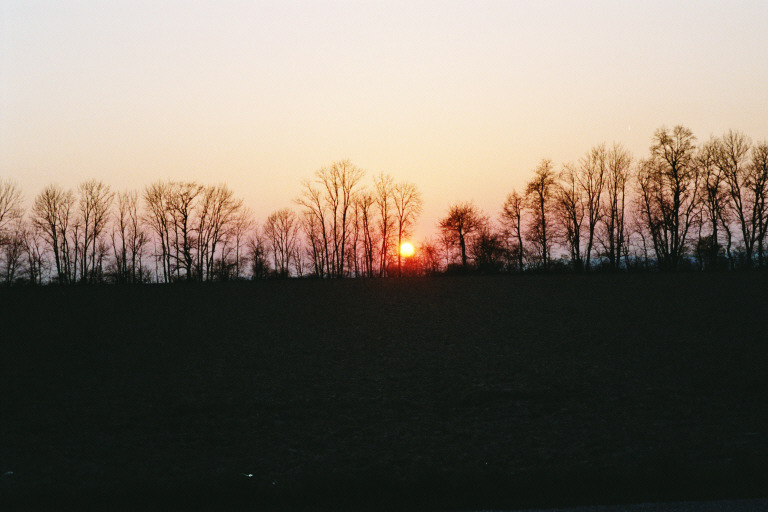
638;126;701;270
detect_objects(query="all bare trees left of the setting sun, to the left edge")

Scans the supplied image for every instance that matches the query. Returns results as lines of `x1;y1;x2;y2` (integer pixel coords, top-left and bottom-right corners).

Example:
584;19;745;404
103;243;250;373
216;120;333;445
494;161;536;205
0;161;422;284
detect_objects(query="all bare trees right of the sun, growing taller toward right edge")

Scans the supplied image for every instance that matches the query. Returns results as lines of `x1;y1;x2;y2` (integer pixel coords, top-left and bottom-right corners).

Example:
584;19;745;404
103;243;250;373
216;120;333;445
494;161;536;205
438;126;768;272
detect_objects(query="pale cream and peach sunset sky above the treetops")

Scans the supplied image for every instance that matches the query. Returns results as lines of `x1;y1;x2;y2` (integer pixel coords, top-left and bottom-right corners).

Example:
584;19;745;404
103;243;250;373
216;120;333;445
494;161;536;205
0;0;768;238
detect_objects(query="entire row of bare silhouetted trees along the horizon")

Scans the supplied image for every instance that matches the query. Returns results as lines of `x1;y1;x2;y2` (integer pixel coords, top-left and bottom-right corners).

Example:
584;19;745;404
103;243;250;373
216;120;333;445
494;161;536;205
0;126;768;284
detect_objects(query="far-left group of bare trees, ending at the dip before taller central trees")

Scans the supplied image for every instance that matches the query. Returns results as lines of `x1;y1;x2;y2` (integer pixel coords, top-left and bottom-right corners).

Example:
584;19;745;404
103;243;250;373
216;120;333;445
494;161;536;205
0;180;250;284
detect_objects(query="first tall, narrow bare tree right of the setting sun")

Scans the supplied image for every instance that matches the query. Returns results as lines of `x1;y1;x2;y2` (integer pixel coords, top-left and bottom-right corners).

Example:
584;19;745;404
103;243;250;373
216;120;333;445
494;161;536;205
526;159;556;270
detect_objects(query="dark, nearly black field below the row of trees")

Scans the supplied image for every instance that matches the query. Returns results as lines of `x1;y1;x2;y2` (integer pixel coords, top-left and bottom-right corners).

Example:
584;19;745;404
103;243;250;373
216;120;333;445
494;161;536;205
0;273;768;510
